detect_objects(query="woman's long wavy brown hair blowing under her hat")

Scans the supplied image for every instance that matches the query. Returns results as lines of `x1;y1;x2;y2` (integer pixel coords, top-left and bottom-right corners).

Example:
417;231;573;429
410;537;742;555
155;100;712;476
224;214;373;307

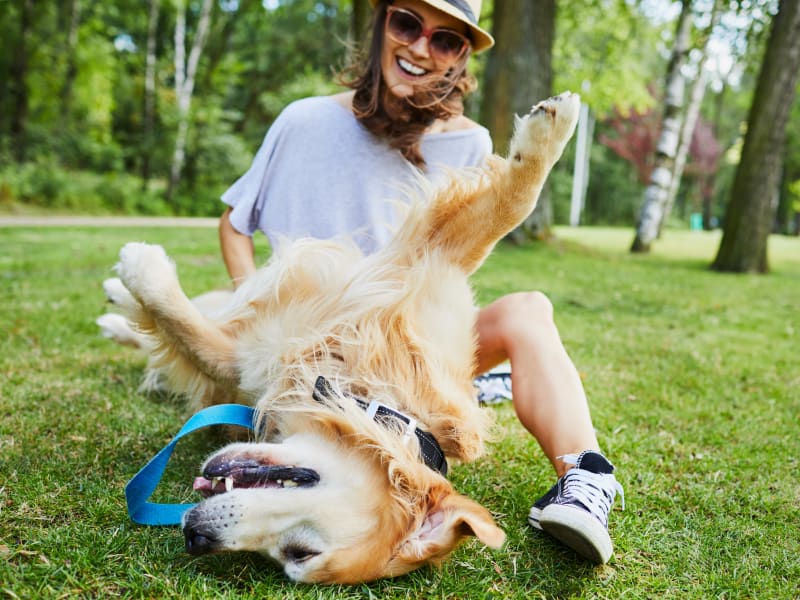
339;0;477;169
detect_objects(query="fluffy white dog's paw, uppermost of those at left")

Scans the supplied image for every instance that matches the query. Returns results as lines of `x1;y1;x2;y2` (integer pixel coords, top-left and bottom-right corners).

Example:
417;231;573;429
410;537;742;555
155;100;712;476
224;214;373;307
116;242;178;304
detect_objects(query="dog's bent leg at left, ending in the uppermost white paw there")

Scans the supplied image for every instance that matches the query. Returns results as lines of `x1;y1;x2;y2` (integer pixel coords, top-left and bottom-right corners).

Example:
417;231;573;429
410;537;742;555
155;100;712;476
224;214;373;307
117;243;238;385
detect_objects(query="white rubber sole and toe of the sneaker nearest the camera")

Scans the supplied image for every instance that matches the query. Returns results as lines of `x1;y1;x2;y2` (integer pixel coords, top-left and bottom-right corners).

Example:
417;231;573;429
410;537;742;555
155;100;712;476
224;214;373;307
528;504;614;565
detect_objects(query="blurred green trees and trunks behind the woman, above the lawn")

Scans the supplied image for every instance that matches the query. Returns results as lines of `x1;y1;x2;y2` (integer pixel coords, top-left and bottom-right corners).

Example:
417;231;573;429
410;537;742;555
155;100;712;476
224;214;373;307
0;0;800;254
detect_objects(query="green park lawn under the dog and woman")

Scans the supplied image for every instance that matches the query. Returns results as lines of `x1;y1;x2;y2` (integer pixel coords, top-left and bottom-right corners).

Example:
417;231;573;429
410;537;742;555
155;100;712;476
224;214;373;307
0;228;800;599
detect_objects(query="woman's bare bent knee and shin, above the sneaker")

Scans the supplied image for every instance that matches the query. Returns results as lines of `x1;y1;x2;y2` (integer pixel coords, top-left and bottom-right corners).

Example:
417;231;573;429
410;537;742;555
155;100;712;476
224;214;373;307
476;292;599;476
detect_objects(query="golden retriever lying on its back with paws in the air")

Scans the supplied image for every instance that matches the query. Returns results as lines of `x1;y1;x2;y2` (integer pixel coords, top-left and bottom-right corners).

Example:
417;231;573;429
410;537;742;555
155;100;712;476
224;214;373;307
100;92;580;583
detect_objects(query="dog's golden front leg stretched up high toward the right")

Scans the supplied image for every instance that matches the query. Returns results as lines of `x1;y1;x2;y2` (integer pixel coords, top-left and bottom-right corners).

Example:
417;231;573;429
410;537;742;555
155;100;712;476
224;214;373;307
416;92;580;273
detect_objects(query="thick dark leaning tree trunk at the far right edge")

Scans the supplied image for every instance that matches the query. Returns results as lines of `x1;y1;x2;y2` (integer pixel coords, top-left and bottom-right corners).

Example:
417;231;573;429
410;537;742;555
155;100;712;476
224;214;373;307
711;0;800;273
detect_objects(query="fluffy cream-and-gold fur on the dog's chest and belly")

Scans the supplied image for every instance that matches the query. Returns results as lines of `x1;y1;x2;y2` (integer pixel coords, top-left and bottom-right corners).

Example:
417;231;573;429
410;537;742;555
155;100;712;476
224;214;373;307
228;241;484;458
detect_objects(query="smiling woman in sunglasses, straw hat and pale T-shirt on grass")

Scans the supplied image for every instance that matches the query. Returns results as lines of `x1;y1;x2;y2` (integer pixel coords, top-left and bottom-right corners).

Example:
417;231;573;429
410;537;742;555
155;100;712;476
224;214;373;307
219;0;622;563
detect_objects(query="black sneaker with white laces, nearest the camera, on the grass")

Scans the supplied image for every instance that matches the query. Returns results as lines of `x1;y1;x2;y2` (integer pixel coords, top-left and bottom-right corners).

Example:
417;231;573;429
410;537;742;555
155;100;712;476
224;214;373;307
528;450;625;564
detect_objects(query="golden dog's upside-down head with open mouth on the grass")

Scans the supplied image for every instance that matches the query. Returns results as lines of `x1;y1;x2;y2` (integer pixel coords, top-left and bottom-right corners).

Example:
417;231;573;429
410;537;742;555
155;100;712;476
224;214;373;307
183;424;505;583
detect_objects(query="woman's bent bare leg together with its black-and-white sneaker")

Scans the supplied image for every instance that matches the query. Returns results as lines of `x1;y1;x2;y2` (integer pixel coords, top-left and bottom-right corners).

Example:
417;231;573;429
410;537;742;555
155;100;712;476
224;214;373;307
476;292;622;563
